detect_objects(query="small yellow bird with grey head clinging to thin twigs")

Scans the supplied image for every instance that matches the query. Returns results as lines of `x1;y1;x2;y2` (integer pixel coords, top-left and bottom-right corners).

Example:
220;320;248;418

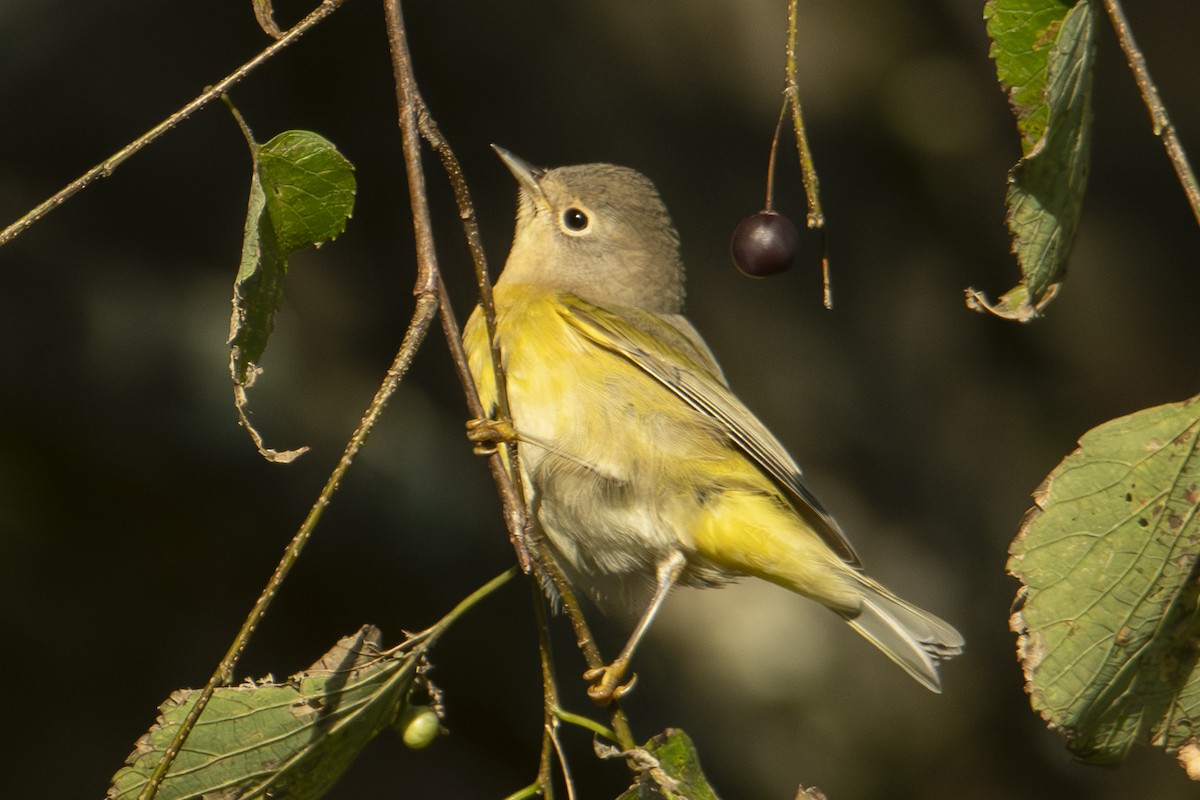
463;145;964;705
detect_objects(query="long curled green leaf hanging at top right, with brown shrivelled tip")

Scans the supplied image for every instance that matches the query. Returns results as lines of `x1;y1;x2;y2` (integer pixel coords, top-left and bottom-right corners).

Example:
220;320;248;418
967;0;1096;321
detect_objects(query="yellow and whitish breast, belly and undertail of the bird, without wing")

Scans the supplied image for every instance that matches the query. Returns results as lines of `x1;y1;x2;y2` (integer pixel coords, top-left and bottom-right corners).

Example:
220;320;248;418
464;284;857;607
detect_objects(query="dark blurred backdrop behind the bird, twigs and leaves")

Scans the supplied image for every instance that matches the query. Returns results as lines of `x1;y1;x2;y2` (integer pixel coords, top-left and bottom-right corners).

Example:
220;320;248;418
0;0;1200;800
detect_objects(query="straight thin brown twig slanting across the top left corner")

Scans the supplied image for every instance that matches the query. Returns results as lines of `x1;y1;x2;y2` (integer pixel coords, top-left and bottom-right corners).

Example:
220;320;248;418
0;0;346;246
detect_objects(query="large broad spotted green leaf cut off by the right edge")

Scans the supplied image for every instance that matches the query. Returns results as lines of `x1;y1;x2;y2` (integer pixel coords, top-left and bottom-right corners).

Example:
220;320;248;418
1008;396;1200;762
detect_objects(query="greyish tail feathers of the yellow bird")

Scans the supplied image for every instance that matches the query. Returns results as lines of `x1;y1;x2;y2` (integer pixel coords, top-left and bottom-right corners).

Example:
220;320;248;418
842;577;964;693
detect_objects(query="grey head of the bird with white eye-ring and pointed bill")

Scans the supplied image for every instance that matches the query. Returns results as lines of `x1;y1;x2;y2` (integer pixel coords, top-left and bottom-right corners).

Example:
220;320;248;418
492;145;684;314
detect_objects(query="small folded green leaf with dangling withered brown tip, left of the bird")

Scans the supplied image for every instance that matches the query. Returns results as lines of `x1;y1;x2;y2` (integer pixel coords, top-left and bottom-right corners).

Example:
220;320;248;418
229;131;355;461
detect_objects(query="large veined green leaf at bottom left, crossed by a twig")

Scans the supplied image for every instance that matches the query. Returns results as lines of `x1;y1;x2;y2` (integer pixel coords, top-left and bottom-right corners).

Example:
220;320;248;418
108;625;424;800
